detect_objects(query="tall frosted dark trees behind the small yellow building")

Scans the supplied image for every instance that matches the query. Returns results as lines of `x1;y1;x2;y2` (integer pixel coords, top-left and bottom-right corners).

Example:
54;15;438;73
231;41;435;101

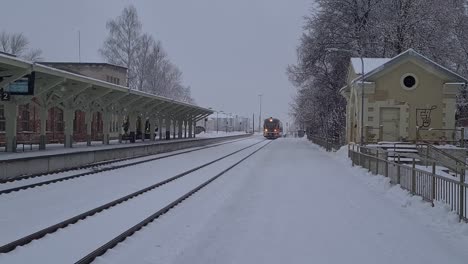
287;0;468;137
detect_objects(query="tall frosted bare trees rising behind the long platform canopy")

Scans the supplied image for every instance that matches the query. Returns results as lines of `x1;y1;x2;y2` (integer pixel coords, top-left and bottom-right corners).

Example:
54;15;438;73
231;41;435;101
99;6;194;103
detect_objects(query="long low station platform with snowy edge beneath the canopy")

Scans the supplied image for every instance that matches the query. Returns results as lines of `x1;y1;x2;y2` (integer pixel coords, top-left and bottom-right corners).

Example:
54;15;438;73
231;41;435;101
0;132;251;180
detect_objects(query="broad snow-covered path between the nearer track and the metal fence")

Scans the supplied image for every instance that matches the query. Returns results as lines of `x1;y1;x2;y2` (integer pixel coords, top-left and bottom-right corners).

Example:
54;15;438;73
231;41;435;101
96;139;468;264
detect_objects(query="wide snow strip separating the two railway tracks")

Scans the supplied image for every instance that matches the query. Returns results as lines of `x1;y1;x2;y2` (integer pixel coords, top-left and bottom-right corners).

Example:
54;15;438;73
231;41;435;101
0;138;262;246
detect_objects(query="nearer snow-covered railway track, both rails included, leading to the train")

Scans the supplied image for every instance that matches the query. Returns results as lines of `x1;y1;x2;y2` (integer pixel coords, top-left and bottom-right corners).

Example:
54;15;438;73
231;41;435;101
0;141;269;263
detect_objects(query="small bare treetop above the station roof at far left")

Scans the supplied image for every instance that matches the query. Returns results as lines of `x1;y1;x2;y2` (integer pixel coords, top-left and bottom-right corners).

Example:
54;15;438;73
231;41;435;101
0;31;42;61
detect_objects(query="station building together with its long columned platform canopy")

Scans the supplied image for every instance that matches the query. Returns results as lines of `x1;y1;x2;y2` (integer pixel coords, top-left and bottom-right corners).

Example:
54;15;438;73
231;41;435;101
0;54;213;152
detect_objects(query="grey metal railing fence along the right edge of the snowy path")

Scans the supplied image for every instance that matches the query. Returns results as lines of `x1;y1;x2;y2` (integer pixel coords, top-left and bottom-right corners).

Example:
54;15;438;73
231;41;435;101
348;145;468;221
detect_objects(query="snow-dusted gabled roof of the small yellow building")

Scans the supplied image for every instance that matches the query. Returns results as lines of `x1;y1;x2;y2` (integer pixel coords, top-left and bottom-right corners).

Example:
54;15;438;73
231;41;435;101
351;49;468;83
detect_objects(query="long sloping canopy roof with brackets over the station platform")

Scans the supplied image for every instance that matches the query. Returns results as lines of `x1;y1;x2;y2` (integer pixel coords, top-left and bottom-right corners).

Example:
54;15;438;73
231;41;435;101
0;54;213;121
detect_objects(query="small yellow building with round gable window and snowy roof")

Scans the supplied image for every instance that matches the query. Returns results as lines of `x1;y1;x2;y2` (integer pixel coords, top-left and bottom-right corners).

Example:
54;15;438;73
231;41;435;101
340;49;467;142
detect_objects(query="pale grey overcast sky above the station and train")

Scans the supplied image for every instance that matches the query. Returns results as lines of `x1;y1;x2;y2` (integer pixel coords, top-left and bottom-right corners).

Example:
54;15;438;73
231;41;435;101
0;0;312;126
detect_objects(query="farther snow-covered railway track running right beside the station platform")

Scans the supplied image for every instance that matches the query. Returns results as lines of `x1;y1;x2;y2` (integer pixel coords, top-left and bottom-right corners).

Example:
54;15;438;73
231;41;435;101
0;138;248;195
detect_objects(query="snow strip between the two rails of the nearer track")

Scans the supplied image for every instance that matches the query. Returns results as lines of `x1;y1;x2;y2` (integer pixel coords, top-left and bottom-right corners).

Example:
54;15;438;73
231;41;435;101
0;143;266;263
